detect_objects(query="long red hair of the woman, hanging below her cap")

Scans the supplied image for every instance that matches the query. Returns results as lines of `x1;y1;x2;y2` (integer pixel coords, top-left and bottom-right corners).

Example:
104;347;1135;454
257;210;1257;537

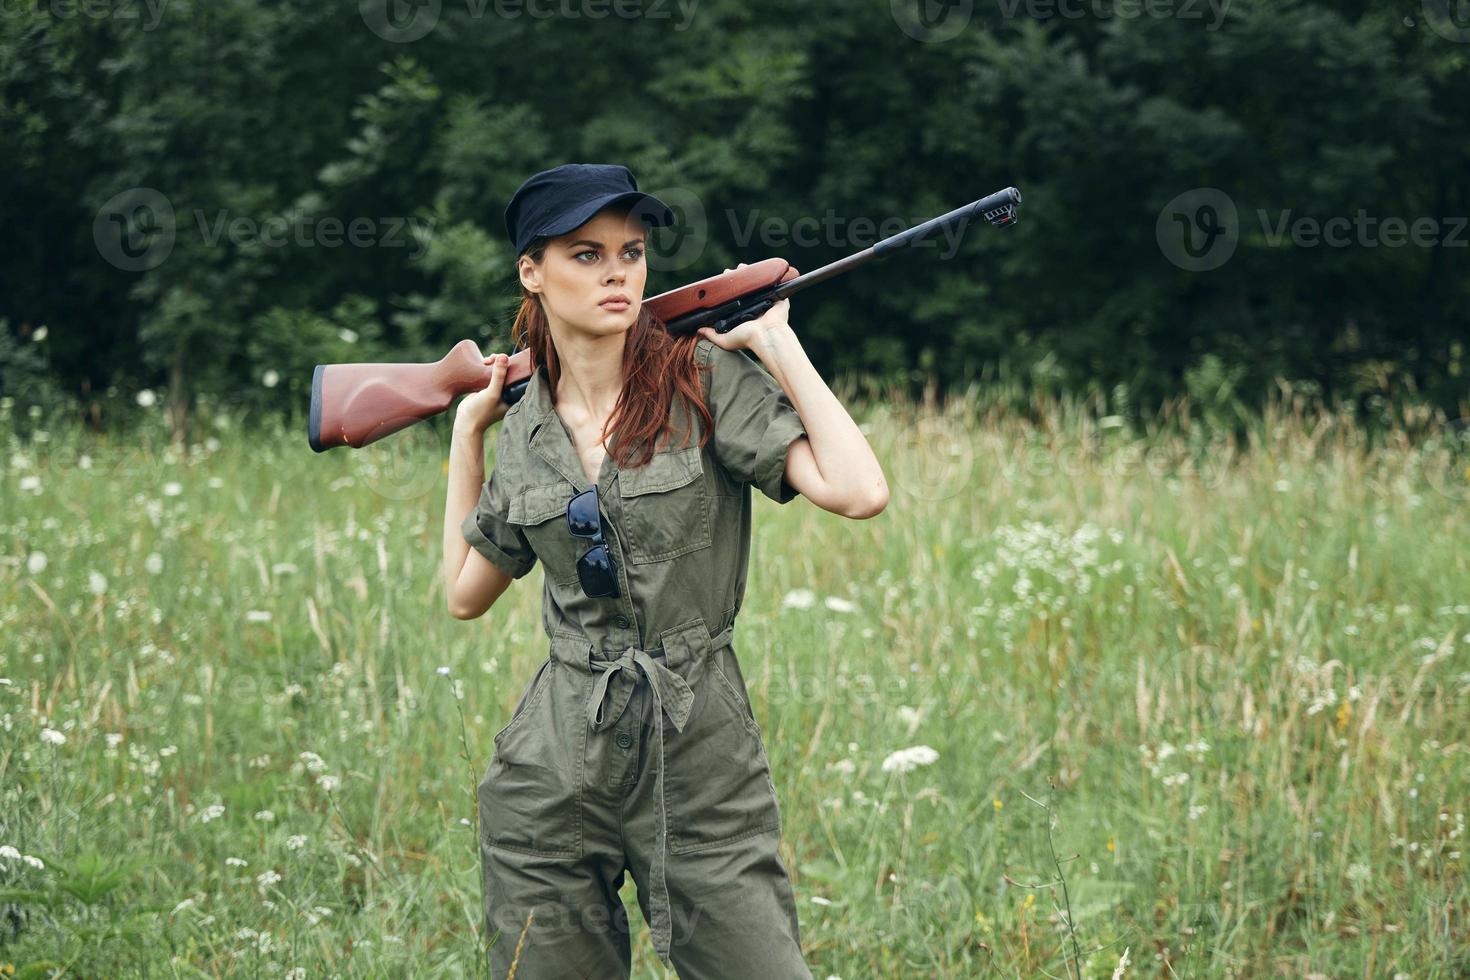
510;239;714;469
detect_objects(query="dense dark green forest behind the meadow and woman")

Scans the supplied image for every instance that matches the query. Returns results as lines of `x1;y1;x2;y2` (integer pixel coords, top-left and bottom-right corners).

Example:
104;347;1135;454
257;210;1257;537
0;0;1470;437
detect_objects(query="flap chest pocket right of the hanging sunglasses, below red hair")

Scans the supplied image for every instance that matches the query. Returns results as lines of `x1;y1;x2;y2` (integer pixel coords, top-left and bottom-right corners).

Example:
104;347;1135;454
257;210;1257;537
617;445;711;564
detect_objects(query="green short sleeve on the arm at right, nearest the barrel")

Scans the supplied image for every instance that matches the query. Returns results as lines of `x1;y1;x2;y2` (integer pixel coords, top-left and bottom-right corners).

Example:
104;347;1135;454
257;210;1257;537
704;341;807;504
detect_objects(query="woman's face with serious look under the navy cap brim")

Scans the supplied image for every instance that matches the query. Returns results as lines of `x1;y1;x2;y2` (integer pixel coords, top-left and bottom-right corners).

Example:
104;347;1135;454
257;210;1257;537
520;209;648;335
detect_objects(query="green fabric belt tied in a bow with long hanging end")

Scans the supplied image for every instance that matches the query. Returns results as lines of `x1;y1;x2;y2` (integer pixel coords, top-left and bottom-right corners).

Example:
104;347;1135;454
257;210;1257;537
587;646;694;962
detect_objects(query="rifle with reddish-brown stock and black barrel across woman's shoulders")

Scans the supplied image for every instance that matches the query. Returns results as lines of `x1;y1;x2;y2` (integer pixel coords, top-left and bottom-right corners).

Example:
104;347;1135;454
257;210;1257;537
307;187;1020;453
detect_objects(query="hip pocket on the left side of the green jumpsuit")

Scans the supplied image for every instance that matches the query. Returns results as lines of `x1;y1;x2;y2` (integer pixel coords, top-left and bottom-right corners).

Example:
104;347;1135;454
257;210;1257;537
476;660;587;857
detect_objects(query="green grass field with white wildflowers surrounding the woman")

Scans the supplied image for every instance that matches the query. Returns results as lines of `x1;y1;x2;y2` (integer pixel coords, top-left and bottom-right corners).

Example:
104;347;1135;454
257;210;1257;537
0;395;1470;980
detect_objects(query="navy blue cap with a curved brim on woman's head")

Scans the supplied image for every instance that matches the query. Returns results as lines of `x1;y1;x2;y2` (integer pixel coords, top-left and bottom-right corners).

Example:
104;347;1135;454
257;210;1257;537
506;163;673;259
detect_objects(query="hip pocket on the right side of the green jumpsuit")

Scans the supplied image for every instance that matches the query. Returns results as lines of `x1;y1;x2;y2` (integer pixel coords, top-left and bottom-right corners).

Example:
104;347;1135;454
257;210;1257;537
664;651;781;854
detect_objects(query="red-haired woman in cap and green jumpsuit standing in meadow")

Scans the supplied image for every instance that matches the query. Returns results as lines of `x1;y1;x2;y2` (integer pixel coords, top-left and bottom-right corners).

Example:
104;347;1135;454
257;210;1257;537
444;165;888;980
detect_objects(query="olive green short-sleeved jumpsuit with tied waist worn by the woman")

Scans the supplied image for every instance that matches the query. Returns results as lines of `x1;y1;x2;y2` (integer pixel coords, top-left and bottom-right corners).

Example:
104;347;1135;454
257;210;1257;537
463;338;811;980
